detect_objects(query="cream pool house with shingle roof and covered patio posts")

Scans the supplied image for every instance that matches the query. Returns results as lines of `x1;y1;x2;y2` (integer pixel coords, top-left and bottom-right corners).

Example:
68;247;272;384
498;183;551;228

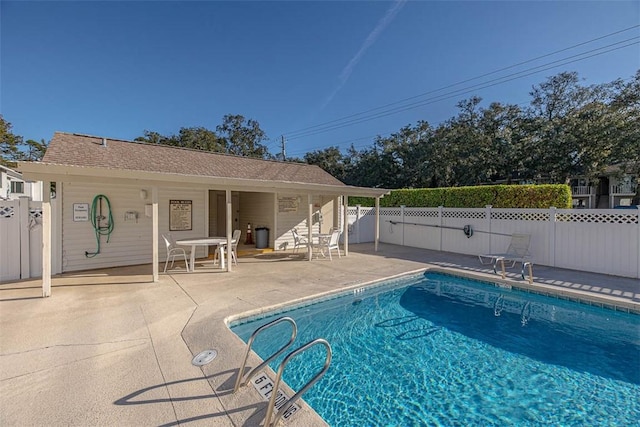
20;132;388;296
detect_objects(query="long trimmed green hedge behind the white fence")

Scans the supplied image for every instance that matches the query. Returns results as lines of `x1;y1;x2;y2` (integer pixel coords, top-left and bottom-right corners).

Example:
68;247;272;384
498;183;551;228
349;184;571;209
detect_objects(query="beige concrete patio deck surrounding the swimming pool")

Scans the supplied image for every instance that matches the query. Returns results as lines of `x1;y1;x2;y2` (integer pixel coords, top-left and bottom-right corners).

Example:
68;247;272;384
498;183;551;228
0;244;640;426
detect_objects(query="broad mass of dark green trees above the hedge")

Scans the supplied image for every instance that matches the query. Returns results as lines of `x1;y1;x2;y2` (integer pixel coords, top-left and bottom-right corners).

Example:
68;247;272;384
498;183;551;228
305;70;640;189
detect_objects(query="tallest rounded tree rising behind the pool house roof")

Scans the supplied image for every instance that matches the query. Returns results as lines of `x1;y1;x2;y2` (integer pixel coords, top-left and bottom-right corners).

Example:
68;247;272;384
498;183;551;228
216;114;272;159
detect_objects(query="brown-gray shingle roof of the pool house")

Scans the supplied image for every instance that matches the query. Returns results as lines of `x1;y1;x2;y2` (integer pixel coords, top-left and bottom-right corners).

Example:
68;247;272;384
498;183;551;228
41;132;344;185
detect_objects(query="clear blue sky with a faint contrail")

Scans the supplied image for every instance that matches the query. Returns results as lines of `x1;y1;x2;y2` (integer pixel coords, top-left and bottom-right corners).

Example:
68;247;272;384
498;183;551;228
0;0;640;157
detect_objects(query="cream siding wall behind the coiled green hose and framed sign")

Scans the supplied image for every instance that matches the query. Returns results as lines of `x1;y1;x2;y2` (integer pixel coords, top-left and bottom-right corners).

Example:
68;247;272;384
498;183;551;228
62;183;206;271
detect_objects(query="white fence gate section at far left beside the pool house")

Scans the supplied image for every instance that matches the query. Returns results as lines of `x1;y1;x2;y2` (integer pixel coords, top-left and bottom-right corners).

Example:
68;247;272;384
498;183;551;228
0;198;42;282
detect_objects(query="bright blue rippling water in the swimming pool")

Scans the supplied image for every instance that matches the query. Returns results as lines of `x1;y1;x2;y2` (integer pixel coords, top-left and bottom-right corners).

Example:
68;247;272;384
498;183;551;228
232;273;640;427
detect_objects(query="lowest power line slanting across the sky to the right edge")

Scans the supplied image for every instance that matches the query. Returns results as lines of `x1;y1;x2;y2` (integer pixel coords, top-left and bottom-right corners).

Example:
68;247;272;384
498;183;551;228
288;36;640;140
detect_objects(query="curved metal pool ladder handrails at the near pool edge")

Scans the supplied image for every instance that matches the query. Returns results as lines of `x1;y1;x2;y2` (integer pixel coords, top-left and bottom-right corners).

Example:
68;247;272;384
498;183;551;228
233;316;333;427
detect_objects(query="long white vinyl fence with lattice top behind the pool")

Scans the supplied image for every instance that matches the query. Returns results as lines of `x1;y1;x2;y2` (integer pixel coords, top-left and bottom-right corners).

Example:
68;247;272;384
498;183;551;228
348;206;640;278
